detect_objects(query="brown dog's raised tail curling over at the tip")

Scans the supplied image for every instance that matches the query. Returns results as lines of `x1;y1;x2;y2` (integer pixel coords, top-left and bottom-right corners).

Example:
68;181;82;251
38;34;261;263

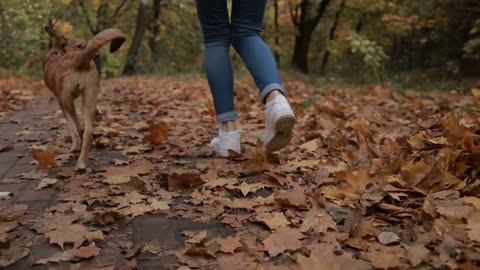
76;28;127;70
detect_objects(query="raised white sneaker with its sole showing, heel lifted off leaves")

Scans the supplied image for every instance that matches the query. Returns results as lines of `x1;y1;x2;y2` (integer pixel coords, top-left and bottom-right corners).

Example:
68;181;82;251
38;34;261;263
264;95;295;152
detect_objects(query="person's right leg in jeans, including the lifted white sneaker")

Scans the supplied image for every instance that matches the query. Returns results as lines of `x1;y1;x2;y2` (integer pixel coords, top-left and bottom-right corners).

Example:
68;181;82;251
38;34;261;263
230;0;295;151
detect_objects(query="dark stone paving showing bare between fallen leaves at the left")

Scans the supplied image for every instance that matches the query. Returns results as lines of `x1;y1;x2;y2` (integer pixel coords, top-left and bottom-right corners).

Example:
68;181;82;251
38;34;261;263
0;96;233;269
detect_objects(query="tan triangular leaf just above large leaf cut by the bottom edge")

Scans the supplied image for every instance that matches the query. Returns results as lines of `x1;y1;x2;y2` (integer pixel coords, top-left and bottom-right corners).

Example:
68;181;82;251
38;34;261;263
300;205;337;234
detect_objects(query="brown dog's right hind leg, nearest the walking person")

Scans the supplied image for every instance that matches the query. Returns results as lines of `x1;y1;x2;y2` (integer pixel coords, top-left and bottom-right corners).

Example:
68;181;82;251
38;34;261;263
76;86;98;171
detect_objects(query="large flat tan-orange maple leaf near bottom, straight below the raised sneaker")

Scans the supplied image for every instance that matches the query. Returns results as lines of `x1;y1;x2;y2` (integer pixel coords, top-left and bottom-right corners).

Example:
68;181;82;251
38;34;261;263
263;227;304;257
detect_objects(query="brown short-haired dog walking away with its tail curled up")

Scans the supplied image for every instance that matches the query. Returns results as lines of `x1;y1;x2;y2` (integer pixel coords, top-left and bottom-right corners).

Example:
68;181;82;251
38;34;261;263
43;26;126;171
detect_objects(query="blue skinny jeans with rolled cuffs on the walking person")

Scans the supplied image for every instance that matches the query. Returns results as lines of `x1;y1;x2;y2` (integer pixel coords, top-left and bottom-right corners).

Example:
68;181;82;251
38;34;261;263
196;0;285;122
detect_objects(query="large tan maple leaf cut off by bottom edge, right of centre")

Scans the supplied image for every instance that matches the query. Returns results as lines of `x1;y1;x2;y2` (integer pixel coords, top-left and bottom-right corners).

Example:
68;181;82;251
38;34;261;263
297;243;372;270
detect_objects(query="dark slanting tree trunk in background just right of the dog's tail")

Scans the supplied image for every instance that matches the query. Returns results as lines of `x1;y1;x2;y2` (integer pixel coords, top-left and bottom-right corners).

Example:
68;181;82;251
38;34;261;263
122;0;150;75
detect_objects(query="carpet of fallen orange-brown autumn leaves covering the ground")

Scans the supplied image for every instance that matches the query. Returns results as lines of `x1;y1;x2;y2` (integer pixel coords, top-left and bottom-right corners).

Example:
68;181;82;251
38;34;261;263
1;77;480;269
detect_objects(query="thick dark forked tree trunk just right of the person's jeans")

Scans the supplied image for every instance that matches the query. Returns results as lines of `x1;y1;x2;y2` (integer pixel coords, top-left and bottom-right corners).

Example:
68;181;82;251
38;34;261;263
292;0;332;73
